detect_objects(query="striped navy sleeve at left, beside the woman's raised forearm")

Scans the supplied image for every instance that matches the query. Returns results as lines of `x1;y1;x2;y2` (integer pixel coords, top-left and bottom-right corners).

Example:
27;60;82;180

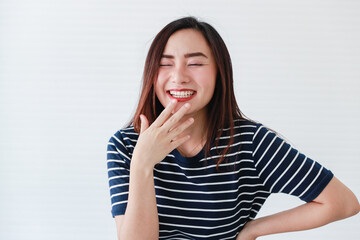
107;131;130;217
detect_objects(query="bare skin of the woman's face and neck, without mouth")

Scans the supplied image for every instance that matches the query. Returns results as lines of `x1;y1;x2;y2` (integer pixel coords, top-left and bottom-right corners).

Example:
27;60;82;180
155;29;217;157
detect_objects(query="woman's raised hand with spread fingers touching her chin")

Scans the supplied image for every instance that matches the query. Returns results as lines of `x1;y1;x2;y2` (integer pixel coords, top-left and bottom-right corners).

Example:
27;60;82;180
131;100;194;170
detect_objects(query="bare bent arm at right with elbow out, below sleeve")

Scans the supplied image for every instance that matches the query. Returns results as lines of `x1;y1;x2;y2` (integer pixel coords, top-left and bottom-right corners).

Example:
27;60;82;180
236;177;360;240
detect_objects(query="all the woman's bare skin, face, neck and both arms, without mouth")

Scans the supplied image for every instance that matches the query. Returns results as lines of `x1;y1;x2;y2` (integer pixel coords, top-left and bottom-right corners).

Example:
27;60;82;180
115;29;360;240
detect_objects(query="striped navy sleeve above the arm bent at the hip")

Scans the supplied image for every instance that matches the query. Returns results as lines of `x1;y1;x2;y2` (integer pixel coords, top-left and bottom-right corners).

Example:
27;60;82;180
252;123;333;202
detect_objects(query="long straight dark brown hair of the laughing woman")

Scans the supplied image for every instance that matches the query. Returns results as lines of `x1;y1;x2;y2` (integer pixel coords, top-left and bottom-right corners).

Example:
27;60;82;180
131;17;253;170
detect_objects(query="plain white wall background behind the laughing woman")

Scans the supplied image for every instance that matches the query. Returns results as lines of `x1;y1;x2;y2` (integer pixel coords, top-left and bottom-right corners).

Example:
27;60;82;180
0;0;360;240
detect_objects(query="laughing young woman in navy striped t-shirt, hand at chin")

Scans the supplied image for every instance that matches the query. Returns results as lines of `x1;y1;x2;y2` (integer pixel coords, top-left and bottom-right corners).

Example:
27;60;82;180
107;17;360;240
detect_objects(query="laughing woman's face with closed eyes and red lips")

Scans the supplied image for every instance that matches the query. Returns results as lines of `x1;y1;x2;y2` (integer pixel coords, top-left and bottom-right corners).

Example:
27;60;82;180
155;29;217;116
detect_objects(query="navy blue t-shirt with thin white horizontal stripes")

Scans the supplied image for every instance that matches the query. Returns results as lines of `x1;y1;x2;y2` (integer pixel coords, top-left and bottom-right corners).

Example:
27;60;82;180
107;120;333;240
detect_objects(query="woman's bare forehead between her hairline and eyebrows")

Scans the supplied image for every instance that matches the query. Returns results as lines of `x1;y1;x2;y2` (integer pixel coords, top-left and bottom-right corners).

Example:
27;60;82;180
164;29;211;54
